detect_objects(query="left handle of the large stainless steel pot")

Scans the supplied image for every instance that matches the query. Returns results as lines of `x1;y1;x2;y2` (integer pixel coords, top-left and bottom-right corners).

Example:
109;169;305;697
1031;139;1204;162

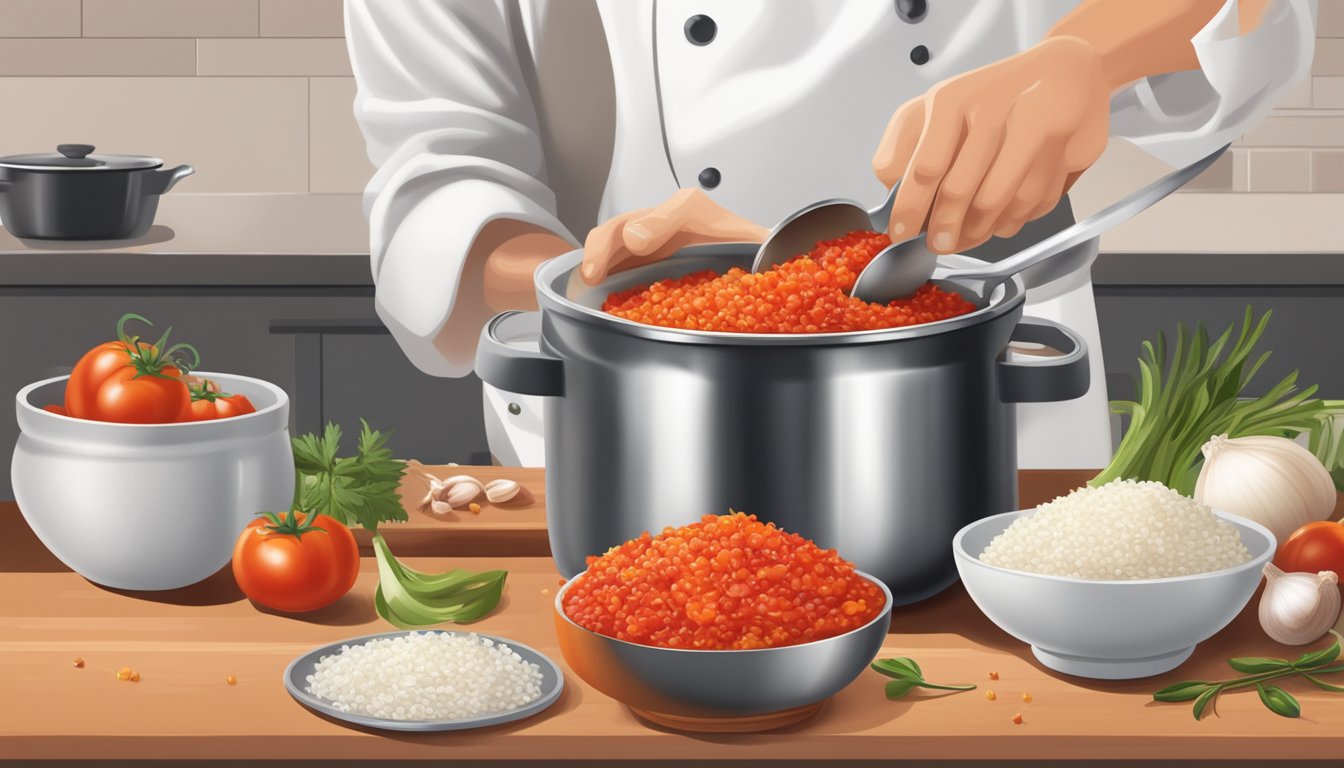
476;311;564;397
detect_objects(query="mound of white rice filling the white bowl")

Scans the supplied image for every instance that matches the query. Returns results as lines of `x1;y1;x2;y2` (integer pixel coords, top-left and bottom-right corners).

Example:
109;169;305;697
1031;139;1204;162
980;480;1251;581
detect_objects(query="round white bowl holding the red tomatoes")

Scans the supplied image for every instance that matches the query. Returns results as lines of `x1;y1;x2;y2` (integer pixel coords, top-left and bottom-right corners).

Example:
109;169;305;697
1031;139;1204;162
11;373;294;589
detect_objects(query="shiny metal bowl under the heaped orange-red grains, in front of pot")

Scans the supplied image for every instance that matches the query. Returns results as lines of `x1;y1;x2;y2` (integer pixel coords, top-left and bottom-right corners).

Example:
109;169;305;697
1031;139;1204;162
555;572;891;732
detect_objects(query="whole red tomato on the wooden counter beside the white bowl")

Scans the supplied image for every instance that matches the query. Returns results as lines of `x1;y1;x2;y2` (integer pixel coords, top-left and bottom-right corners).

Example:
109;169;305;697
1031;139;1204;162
234;512;359;613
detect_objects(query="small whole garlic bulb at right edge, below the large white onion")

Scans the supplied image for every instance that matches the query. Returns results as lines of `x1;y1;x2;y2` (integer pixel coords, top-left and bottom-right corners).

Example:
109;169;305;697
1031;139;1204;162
1259;562;1340;646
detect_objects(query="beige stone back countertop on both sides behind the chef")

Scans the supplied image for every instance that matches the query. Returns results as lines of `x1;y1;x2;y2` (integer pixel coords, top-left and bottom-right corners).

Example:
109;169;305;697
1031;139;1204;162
0;192;1344;288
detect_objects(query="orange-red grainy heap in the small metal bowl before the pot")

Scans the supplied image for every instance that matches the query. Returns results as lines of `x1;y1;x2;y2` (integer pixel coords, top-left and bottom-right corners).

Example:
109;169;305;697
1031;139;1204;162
562;512;886;651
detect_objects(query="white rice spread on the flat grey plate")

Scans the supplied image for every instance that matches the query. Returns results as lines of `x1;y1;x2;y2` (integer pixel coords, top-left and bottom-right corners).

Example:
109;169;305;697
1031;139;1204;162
304;632;542;721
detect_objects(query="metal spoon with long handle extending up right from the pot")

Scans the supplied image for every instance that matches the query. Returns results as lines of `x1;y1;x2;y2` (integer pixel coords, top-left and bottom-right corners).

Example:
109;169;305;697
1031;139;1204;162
849;144;1227;304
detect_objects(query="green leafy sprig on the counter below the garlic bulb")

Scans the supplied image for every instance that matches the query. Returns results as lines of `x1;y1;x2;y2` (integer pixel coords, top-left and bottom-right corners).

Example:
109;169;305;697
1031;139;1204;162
1153;629;1344;720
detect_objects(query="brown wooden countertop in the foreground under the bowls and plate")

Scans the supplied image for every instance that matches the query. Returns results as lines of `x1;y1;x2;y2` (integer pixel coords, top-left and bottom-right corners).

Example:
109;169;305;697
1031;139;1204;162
0;468;1344;763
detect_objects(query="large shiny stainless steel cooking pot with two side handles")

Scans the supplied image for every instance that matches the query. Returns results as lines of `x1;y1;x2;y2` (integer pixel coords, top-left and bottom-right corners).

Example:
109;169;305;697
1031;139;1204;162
476;245;1089;604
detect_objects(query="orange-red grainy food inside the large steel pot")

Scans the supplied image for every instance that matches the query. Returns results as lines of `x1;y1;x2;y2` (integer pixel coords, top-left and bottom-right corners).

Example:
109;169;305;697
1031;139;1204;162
602;231;976;334
